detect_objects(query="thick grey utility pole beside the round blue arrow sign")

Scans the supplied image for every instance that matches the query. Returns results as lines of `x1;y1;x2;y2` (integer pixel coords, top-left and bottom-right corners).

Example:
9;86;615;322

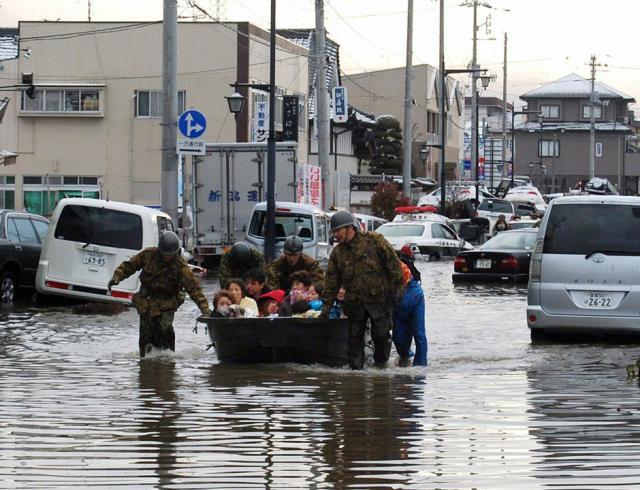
160;0;178;223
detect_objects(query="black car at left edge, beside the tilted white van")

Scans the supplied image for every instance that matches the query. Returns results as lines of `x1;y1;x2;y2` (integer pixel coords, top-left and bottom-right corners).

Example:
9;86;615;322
0;210;49;303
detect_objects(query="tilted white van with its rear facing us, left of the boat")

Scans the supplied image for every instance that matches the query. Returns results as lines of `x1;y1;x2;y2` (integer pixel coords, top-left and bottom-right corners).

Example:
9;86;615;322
36;198;174;304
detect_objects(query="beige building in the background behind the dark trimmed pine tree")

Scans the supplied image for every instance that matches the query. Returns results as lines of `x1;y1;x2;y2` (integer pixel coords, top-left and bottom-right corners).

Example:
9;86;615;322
343;64;464;180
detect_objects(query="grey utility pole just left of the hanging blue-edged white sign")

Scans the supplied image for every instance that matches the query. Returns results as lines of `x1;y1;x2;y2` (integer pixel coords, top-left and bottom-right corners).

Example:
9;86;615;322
315;0;334;209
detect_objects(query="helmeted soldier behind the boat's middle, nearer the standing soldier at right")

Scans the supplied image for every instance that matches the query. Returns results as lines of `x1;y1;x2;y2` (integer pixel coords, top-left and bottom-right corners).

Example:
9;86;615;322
267;235;324;291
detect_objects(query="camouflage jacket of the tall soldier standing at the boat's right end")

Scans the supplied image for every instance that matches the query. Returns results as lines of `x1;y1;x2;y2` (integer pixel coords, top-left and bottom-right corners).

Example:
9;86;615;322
322;231;404;308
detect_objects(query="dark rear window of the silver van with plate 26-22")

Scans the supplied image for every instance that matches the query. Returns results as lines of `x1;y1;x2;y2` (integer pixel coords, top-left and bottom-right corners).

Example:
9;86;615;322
543;203;640;255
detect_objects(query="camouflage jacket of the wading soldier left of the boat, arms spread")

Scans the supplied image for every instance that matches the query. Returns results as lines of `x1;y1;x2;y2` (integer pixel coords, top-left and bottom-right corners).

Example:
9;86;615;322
112;247;211;316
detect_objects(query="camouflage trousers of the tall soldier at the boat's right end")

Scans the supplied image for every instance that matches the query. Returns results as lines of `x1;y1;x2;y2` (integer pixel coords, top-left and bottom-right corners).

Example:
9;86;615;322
344;303;393;369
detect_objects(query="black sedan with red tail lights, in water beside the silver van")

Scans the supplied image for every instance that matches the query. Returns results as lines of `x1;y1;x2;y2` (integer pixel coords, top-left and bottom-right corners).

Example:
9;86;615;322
453;228;538;282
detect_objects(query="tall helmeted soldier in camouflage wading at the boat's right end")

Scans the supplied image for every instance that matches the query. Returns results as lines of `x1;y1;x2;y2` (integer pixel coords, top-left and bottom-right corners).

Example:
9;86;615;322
322;211;404;369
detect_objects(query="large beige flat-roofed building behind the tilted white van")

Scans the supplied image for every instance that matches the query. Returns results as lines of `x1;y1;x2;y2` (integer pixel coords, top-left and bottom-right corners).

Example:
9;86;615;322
0;22;309;214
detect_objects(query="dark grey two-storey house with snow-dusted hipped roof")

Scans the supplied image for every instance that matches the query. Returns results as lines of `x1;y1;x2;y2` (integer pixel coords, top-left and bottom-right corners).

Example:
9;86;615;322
514;73;640;192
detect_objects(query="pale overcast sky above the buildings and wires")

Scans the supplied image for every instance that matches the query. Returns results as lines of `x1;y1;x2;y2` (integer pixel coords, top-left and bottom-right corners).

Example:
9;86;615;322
5;0;640;108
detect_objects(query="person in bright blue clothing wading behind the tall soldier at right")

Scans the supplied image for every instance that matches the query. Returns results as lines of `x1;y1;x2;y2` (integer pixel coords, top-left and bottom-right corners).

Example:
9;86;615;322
393;247;428;366
